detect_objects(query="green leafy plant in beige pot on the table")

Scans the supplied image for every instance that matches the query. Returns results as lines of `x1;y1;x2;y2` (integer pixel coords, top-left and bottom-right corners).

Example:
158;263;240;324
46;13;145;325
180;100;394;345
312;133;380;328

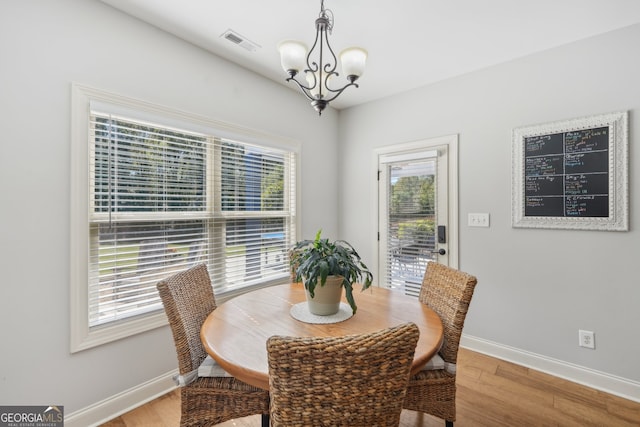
291;230;373;315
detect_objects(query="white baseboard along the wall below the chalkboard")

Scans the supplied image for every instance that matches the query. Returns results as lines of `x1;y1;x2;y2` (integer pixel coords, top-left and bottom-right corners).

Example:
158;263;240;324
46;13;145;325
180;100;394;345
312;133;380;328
460;334;640;403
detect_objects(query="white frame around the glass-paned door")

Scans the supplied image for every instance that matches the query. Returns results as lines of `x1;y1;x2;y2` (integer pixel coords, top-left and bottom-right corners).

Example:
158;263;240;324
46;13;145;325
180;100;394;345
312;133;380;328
372;134;459;284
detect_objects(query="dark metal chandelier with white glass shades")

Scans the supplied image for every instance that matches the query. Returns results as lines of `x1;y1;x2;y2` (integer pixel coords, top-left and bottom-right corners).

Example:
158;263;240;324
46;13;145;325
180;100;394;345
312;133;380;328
278;0;367;115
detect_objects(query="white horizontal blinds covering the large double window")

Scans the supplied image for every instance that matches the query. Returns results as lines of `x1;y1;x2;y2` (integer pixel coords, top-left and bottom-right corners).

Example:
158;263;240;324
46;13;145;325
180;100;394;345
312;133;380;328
88;110;296;328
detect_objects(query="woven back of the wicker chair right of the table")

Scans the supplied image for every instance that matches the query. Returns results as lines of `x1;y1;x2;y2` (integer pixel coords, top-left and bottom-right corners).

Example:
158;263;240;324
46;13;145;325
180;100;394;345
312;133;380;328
419;262;478;363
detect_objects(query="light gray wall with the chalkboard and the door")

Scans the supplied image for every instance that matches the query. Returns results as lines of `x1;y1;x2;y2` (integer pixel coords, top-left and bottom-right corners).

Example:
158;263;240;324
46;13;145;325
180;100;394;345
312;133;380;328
339;25;640;384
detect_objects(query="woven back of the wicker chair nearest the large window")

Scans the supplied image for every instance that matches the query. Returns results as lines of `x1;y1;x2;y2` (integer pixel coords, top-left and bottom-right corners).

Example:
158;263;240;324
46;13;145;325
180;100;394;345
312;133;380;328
157;264;216;375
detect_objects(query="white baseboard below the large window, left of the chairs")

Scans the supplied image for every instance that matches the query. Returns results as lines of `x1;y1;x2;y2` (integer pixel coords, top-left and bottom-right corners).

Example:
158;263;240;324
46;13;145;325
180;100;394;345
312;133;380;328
64;369;178;427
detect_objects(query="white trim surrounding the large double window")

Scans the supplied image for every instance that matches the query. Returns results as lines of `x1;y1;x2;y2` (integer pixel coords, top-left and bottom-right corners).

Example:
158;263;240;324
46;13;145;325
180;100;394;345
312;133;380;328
69;83;302;353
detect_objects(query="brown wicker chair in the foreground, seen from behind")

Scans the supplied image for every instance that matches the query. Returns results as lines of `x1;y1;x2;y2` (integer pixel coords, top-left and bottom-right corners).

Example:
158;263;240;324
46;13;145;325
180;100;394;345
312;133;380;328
267;323;420;427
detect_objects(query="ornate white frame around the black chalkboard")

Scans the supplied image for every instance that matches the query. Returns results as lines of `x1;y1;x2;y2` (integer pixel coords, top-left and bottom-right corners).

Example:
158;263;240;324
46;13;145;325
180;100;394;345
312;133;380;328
511;111;629;231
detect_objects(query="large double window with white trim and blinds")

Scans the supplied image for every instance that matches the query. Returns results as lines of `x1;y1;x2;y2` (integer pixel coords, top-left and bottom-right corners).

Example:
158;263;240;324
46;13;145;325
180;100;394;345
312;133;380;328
71;85;298;351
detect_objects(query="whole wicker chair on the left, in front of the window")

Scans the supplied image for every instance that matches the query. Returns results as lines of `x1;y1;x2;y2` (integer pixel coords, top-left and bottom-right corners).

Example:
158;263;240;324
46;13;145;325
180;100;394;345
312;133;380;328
157;264;269;426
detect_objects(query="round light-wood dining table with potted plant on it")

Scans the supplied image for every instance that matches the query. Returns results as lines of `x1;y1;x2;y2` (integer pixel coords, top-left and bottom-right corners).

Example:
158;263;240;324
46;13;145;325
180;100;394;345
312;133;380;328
200;283;443;390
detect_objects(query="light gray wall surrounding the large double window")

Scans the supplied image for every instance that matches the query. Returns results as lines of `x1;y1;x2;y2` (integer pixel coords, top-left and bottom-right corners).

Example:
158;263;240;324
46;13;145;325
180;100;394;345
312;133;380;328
0;0;338;414
